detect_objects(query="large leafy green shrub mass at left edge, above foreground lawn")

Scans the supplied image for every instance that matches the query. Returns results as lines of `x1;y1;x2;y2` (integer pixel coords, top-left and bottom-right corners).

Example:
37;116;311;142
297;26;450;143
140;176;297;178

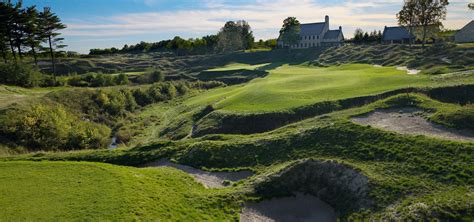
0;104;110;150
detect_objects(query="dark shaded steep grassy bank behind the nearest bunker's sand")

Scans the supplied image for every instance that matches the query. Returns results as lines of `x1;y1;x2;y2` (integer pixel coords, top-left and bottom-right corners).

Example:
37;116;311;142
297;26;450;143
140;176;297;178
256;159;373;217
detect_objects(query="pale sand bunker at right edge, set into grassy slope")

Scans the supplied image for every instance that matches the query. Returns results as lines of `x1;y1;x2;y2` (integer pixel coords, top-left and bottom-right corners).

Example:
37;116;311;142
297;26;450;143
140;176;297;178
352;108;474;141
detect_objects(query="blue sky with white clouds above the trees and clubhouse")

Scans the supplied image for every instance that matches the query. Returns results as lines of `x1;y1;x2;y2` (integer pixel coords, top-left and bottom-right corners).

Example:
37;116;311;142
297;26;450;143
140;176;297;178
23;0;474;53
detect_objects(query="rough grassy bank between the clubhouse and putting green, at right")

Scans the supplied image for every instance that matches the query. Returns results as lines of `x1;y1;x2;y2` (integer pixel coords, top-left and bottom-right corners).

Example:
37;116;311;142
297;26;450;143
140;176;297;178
314;45;474;74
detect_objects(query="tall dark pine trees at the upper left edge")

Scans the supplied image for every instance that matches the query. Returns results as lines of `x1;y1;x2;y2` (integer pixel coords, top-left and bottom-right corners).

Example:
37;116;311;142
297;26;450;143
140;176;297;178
0;0;66;78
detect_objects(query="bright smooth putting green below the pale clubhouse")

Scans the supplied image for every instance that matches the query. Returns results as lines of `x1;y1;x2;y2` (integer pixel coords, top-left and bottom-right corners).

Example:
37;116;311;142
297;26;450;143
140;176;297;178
186;64;432;112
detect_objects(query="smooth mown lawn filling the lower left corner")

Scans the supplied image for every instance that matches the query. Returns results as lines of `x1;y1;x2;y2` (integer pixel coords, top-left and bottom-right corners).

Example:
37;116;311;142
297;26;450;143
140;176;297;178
0;162;237;221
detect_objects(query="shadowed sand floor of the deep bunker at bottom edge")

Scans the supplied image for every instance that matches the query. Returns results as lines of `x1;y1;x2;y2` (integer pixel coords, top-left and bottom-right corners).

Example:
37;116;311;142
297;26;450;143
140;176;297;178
240;194;336;222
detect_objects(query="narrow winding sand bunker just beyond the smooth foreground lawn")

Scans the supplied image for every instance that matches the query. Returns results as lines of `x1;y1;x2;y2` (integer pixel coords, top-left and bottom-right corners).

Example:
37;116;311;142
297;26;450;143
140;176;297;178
143;160;253;188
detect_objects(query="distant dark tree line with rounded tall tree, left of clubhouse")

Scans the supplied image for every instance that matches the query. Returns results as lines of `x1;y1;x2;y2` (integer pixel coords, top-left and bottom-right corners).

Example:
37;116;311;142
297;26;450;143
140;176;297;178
89;20;276;55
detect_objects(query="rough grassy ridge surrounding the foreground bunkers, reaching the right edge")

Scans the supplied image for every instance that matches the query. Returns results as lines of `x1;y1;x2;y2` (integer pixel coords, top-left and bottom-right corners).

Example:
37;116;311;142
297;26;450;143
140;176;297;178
3;94;474;221
